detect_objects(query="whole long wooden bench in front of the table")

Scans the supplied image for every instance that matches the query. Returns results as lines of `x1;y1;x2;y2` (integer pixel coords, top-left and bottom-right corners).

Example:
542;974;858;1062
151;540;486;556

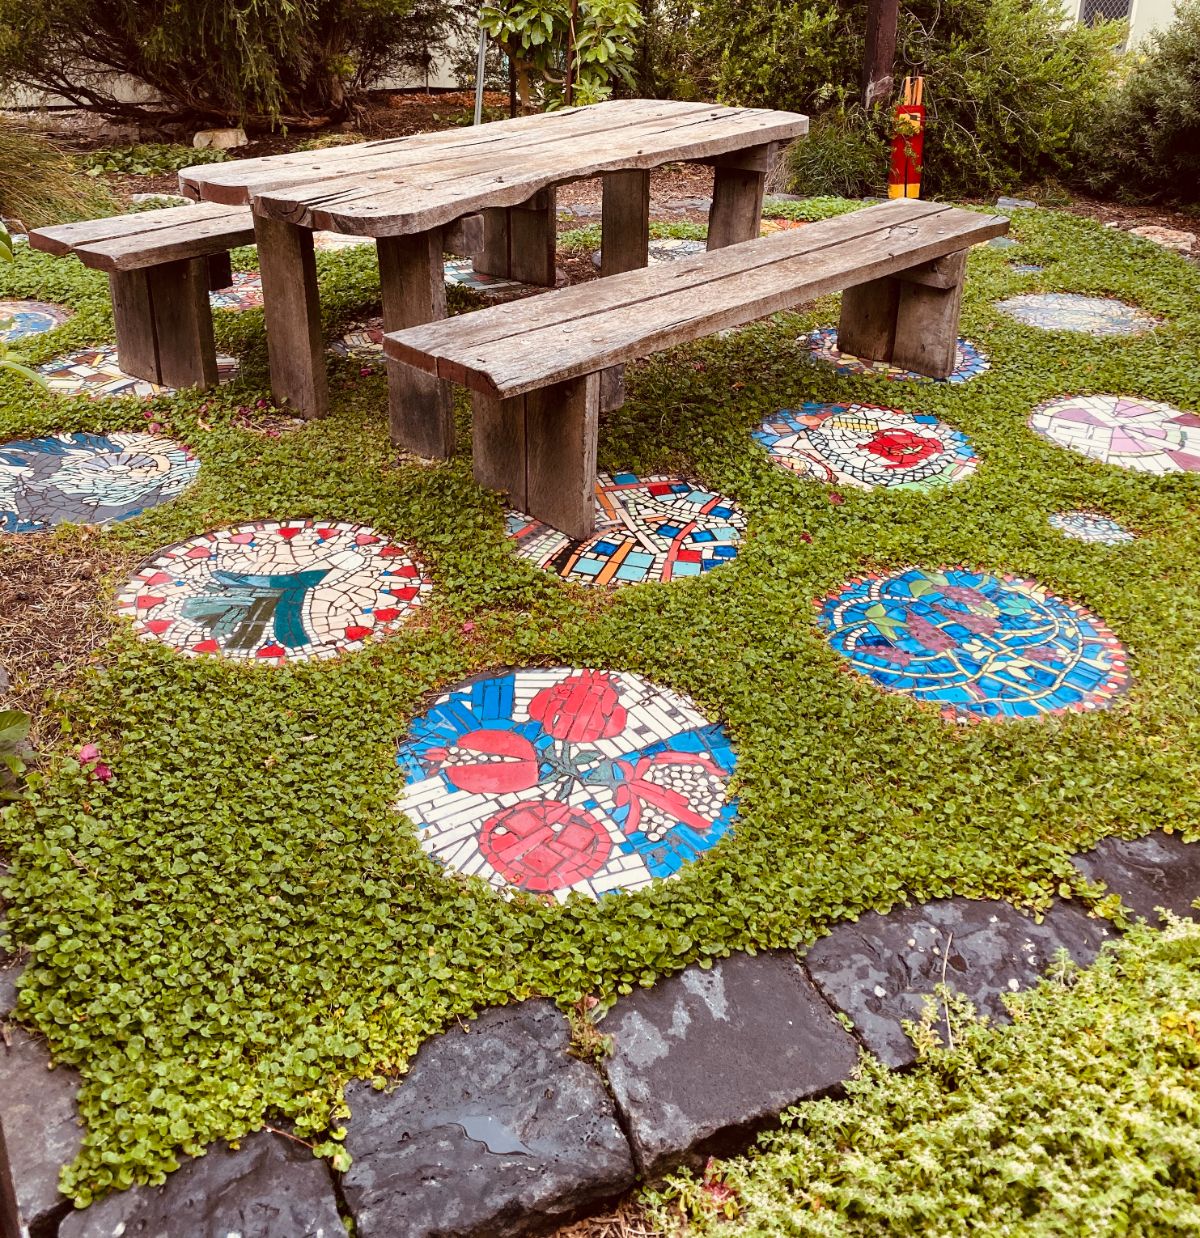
384;199;1008;537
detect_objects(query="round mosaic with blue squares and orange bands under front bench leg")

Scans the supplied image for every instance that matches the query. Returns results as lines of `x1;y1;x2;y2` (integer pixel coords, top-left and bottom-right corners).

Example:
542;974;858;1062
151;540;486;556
508;473;746;586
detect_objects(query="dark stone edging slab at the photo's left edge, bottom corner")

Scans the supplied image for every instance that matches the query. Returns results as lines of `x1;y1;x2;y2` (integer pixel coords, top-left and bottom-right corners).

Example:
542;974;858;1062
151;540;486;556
0;1018;83;1238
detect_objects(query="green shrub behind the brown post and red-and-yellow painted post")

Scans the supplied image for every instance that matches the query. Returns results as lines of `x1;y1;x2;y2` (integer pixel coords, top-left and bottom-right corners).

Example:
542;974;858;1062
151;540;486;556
696;0;1124;196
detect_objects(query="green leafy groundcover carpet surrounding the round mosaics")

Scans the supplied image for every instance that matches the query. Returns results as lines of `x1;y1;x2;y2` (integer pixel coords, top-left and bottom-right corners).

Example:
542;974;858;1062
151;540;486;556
0;212;1200;1202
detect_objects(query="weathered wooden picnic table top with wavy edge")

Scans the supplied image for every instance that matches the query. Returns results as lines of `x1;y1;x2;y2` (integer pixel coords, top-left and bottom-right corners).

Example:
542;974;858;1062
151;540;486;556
180;99;809;236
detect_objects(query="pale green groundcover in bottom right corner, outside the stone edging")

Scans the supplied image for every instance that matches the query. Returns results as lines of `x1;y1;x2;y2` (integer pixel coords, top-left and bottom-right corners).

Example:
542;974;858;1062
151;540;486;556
654;920;1200;1238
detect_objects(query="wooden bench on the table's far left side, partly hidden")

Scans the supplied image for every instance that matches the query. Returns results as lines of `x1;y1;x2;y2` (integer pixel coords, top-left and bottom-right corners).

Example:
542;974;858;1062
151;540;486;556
30;202;254;387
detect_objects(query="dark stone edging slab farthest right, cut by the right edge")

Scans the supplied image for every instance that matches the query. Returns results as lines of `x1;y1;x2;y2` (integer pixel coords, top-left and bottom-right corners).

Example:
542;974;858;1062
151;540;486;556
1075;829;1200;920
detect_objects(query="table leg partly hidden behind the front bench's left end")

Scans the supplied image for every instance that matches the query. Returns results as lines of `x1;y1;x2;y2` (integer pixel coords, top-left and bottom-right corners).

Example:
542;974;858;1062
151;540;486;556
376;228;454;459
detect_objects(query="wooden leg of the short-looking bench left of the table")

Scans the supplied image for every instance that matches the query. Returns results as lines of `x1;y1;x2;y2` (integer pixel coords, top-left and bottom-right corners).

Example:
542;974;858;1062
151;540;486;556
109;258;217;387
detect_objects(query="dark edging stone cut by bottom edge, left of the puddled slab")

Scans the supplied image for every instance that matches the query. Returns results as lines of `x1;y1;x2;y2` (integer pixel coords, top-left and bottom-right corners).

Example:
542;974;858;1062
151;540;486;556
58;1130;346;1238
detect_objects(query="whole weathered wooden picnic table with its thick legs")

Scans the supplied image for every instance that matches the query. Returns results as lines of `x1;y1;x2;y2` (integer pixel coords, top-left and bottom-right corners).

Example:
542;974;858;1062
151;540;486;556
180;99;809;457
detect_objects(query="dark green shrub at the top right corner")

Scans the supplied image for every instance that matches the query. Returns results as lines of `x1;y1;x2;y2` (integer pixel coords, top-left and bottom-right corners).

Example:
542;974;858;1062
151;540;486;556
1079;0;1200;202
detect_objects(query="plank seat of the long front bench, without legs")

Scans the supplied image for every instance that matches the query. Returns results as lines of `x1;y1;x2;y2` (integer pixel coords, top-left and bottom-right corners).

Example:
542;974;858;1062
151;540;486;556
384;199;1008;397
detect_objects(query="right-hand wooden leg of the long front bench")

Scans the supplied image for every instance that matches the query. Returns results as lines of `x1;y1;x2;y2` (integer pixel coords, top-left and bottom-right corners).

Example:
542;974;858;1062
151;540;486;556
837;250;967;379
